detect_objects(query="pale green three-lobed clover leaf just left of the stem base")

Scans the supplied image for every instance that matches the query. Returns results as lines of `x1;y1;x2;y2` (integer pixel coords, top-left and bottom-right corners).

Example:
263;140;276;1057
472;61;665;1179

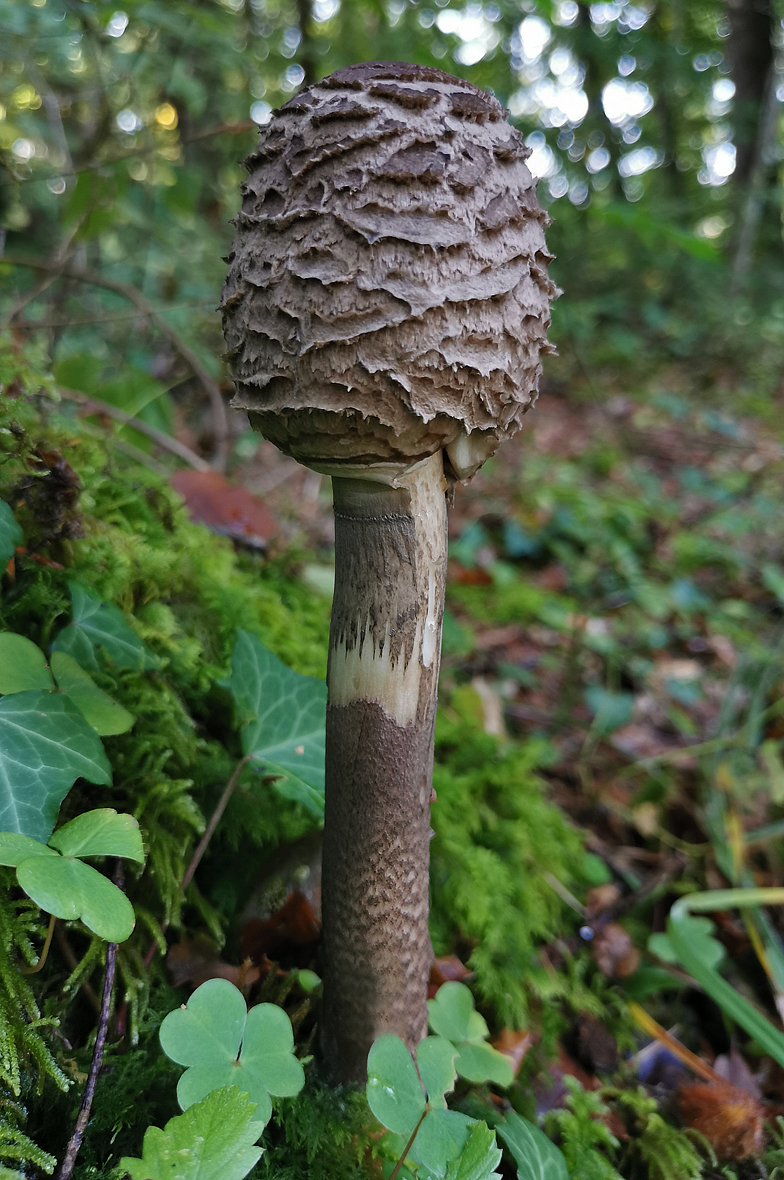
159;979;305;1126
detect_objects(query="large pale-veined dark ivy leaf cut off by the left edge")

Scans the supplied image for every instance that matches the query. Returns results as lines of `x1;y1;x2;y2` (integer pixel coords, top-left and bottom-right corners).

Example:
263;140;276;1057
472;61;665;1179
0;691;111;843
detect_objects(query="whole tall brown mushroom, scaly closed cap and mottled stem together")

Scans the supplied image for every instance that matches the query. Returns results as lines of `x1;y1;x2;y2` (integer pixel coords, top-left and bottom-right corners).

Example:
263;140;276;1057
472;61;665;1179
222;61;555;1082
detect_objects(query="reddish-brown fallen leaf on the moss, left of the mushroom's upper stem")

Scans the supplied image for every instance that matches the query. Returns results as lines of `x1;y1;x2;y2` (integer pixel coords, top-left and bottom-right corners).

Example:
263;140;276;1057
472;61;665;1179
171;468;277;549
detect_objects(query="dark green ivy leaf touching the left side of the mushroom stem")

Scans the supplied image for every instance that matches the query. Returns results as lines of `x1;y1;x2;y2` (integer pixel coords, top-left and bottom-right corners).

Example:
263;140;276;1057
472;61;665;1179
228;631;327;815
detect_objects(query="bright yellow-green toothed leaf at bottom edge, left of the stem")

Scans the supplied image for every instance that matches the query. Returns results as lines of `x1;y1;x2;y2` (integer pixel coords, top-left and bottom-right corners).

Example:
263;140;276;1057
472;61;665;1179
119;1086;264;1180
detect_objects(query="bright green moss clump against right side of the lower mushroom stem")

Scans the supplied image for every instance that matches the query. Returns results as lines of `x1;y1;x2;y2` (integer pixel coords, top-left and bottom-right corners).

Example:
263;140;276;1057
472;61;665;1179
431;693;583;1027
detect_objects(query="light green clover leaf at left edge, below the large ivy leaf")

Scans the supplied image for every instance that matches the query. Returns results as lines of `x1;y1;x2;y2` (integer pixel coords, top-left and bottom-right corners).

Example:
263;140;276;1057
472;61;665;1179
0;807;144;943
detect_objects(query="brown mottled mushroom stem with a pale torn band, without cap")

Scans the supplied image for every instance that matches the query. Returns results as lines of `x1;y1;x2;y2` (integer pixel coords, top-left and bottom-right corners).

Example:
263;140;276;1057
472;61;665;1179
322;451;446;1082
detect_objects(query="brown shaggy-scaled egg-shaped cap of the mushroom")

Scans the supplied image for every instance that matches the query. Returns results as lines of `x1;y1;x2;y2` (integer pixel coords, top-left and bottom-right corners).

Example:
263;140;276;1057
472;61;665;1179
221;61;556;478
